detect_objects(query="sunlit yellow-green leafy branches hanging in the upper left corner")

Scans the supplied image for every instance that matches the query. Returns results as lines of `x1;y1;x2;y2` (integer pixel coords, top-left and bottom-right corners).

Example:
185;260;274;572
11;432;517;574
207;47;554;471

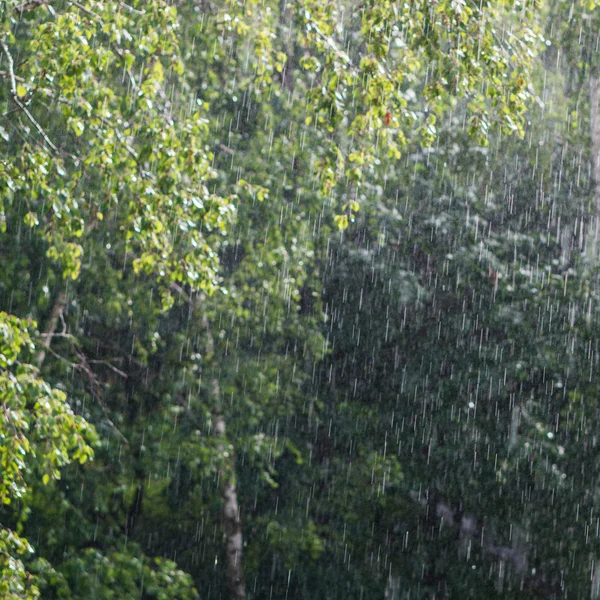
0;1;232;303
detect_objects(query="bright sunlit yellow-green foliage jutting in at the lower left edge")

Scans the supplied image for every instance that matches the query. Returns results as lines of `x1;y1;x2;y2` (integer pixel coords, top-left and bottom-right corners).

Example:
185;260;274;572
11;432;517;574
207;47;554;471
0;312;96;598
